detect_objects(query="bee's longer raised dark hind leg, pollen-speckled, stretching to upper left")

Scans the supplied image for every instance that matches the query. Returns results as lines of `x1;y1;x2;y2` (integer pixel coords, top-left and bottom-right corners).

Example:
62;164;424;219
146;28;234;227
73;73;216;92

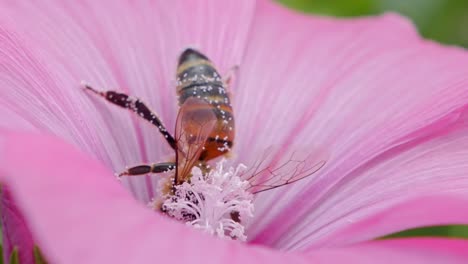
82;83;177;149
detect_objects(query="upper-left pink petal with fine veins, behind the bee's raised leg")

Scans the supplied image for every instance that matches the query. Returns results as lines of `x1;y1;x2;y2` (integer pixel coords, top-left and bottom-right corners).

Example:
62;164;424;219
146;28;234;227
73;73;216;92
0;0;255;201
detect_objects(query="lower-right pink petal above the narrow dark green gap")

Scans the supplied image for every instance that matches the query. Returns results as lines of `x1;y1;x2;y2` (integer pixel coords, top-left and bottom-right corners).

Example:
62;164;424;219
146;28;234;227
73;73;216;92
262;110;468;248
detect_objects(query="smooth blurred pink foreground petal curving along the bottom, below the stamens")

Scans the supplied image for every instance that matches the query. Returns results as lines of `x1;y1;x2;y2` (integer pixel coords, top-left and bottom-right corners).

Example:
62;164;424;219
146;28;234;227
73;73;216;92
0;132;468;264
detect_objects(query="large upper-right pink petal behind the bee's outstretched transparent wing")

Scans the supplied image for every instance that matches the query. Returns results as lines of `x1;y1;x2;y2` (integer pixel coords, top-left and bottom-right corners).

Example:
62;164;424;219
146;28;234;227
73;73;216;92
241;1;468;245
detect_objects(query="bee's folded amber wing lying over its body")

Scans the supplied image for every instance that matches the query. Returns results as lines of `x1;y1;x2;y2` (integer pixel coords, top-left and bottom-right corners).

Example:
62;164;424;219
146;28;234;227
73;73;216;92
175;98;217;184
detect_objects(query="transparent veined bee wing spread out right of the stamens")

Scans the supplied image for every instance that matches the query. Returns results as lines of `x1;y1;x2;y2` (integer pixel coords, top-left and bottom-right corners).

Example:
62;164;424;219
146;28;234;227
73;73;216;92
241;147;326;194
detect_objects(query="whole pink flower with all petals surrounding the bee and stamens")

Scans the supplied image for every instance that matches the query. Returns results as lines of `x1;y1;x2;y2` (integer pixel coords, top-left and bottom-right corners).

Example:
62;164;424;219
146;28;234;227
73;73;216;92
0;0;468;264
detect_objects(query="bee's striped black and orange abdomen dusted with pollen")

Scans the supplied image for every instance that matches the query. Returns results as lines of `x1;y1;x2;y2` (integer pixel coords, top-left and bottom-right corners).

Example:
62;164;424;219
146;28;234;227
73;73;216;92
177;49;235;161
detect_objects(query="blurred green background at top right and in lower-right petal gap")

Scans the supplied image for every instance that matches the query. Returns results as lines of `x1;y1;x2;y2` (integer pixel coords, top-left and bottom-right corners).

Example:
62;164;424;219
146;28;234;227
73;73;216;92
279;0;468;239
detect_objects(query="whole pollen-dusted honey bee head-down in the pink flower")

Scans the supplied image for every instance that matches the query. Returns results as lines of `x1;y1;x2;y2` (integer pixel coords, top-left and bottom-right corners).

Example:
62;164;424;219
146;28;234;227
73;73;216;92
84;48;324;198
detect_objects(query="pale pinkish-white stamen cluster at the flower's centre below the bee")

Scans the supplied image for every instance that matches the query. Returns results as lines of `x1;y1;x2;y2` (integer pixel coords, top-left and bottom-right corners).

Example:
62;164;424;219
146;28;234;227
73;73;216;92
162;160;254;241
